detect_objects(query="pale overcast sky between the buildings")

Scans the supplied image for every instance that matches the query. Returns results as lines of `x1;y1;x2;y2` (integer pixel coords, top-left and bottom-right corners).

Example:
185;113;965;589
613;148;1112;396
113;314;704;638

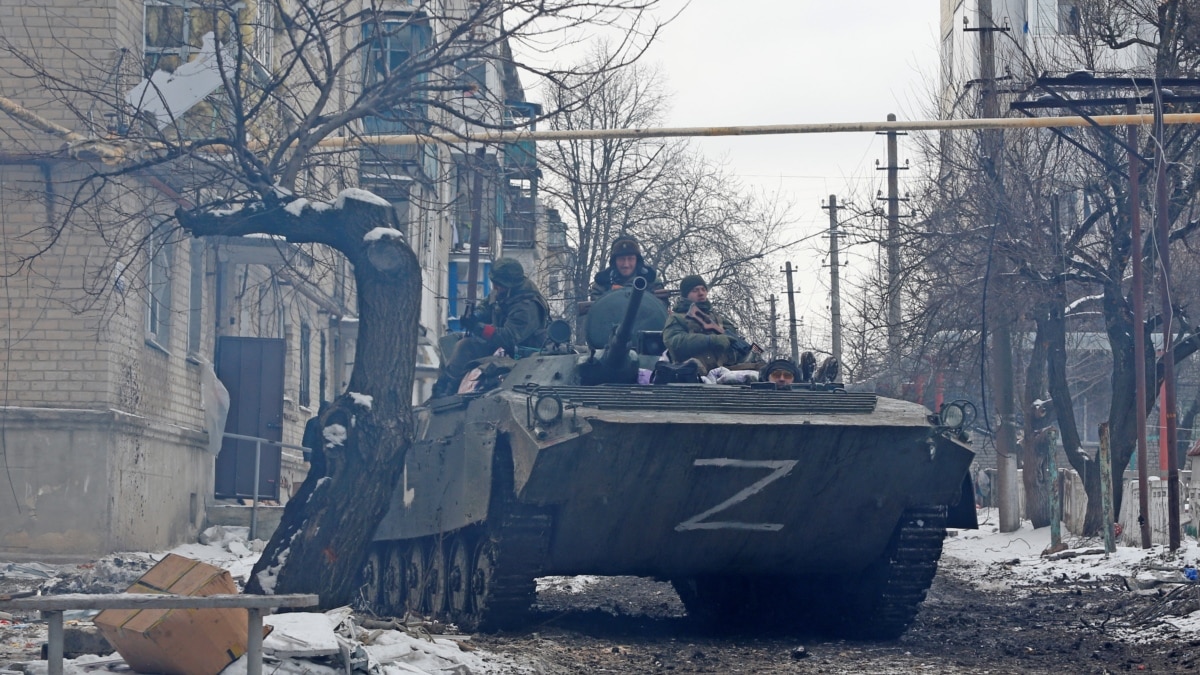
525;0;938;341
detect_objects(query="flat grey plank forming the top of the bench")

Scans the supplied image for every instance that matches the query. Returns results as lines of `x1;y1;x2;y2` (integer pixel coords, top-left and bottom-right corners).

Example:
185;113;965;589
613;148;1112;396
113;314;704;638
0;593;319;611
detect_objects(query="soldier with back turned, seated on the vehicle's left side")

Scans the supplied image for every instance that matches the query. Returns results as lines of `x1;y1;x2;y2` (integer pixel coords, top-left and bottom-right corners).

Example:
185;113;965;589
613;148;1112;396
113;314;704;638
433;258;550;398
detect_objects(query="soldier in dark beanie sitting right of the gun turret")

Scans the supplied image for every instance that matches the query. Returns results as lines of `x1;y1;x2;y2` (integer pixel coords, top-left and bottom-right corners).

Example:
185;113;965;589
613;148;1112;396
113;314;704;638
662;274;756;371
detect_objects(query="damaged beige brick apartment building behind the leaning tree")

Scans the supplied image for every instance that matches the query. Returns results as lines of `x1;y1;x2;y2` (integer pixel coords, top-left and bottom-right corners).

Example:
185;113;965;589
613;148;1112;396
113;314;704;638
0;0;558;560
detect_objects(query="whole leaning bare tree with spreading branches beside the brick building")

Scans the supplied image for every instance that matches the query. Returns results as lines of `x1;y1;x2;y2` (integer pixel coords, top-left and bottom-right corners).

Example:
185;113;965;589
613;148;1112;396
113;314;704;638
0;0;658;607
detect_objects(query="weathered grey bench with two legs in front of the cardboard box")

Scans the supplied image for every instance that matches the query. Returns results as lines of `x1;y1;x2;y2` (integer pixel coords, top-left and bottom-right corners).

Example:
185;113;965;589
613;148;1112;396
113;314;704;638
0;593;319;675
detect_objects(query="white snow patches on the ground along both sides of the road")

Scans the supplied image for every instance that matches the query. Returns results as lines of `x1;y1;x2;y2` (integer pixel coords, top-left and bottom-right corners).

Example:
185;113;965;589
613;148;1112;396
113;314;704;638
11;509;1200;675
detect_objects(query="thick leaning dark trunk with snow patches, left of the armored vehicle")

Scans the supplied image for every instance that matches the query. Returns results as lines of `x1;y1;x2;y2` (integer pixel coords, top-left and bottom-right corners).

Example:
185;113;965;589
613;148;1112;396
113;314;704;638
180;199;421;609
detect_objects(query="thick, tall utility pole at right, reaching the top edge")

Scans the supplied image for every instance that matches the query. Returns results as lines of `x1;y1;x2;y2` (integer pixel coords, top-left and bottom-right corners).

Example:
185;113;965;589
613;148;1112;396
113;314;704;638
967;0;1017;532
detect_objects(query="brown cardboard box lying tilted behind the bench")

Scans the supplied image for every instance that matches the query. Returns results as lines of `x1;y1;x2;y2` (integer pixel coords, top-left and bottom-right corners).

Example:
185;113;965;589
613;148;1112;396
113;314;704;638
92;554;250;675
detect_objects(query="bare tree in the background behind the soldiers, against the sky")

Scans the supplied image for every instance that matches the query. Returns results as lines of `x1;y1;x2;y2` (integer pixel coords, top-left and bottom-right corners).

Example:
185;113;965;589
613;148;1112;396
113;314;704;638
541;47;794;336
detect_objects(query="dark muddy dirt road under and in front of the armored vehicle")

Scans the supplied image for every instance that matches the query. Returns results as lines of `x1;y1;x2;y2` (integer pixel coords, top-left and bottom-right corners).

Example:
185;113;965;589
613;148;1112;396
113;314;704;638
476;558;1200;675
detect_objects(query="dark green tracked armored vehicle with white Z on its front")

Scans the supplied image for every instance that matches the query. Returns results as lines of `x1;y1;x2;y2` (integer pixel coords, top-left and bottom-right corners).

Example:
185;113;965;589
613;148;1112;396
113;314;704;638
362;278;974;638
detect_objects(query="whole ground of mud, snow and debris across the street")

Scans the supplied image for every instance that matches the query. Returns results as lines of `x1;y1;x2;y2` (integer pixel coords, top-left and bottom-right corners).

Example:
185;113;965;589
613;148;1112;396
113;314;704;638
7;510;1200;675
